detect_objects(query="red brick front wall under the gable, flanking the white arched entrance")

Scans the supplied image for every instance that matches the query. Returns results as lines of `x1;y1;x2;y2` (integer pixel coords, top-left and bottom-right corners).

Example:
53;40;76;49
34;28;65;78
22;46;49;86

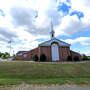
39;43;70;61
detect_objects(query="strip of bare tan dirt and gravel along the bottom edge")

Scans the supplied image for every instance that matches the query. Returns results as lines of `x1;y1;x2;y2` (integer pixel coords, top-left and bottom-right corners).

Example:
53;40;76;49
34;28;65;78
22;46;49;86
0;84;90;90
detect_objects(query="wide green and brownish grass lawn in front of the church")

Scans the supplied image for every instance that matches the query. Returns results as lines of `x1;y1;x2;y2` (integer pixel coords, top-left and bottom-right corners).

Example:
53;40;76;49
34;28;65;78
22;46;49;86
0;61;90;85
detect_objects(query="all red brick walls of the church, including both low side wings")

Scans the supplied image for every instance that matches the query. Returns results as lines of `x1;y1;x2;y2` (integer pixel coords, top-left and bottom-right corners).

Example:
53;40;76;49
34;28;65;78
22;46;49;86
16;44;81;62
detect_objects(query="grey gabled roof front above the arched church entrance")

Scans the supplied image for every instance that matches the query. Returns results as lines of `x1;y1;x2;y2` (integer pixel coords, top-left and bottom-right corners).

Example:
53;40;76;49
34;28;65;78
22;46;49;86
39;38;70;47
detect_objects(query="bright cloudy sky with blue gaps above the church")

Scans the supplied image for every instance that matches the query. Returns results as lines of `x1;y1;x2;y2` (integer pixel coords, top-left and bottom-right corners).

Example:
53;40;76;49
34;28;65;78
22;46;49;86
0;0;90;55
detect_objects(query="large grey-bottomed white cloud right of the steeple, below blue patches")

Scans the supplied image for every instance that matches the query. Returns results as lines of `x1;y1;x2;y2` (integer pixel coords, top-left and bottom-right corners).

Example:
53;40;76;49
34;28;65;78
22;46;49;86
57;15;90;36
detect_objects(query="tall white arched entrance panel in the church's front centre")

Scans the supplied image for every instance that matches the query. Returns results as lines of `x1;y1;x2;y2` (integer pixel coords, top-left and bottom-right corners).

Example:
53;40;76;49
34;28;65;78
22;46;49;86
51;44;59;61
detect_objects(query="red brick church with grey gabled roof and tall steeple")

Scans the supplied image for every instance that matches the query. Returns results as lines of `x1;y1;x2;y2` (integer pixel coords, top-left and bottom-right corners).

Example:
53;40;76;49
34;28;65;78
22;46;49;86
16;23;81;62
